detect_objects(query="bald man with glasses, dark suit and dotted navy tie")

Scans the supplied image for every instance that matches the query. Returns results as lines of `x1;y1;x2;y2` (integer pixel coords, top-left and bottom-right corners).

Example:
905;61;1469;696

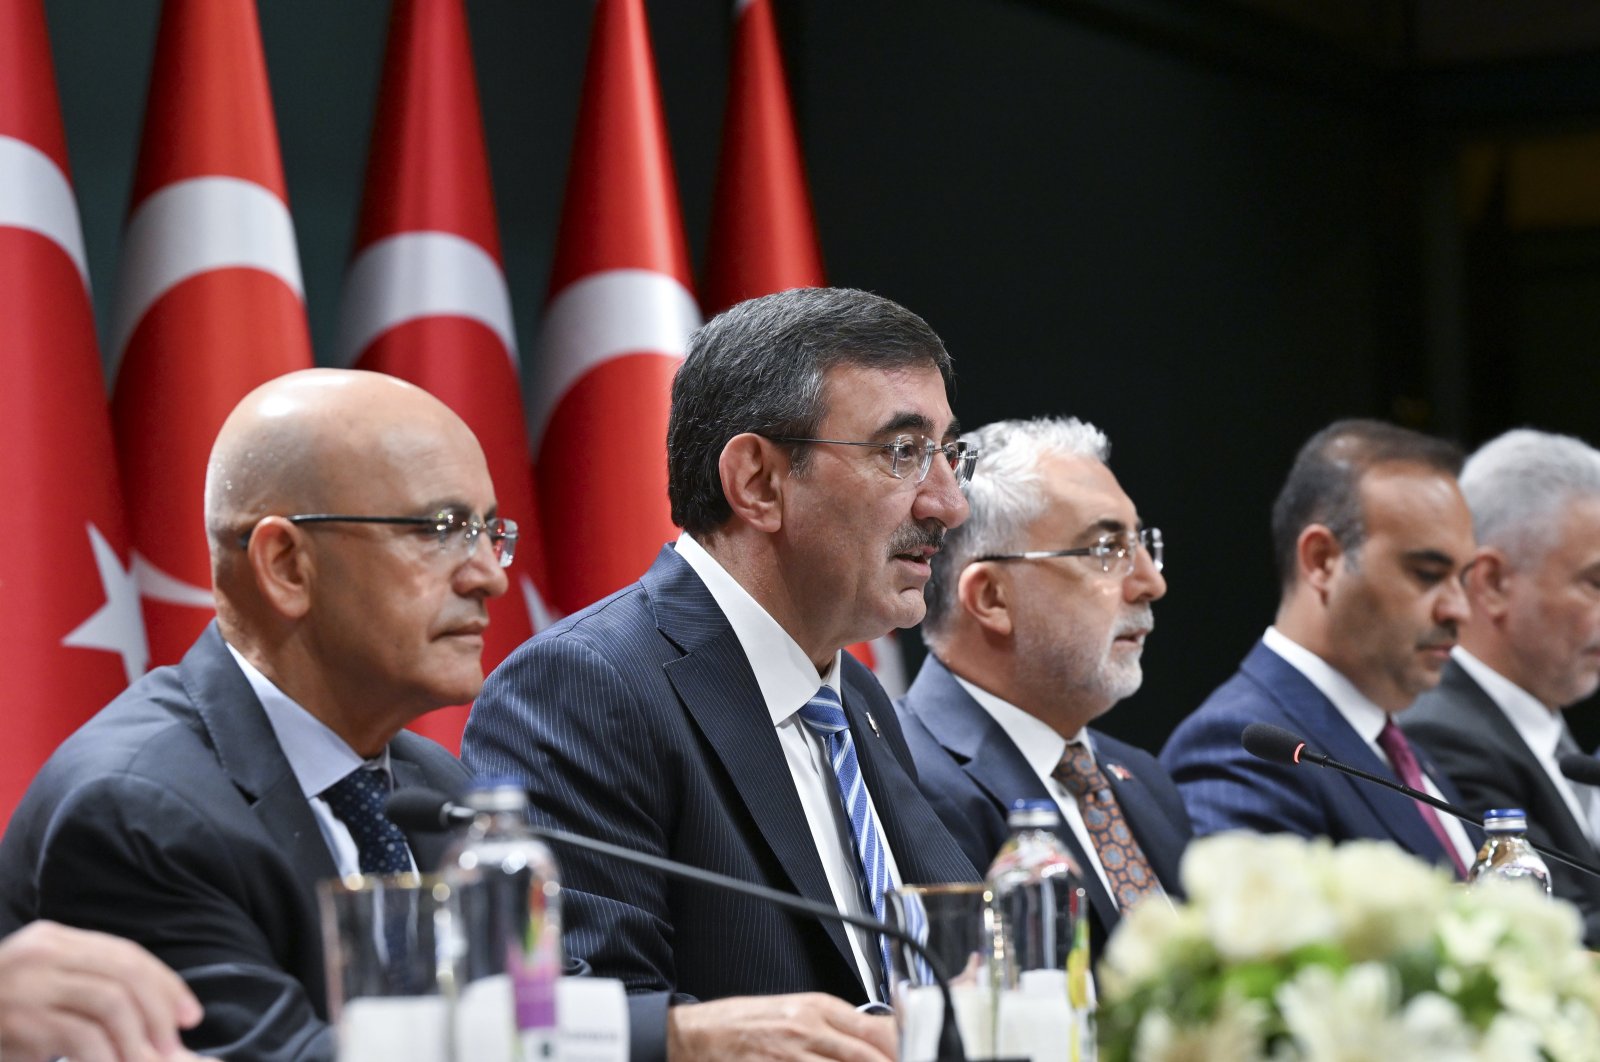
0;369;502;1062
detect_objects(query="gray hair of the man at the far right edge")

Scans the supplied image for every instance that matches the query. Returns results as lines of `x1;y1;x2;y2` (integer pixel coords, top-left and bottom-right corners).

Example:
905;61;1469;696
1461;427;1600;563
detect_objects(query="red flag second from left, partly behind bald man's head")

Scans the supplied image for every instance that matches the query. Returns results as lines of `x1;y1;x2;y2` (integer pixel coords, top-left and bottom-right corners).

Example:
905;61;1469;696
112;0;312;664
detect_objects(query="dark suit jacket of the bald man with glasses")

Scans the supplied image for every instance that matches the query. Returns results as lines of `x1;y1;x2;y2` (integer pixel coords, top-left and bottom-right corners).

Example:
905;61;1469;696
0;624;467;1062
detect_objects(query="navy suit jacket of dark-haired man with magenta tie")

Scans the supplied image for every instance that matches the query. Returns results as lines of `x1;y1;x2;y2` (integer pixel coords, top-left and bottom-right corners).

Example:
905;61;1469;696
1162;643;1459;873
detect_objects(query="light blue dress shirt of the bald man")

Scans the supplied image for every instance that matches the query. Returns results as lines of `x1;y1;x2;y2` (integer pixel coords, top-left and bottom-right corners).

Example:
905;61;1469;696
224;643;416;878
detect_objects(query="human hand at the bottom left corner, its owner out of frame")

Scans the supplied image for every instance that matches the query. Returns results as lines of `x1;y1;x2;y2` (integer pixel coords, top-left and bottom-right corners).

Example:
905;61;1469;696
0;921;202;1062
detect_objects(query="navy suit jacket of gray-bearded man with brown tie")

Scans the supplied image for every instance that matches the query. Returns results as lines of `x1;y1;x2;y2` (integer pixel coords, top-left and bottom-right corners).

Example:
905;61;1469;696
894;656;1194;955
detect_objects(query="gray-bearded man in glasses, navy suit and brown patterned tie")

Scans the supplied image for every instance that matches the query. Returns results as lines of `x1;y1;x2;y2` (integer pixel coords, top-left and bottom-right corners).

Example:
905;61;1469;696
896;419;1190;939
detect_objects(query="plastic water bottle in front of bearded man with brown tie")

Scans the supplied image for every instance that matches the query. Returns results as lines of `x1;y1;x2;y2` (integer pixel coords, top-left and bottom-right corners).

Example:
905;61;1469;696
987;800;1094;1062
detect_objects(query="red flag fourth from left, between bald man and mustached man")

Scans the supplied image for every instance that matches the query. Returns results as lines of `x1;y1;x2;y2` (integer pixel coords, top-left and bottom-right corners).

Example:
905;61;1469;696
528;0;699;613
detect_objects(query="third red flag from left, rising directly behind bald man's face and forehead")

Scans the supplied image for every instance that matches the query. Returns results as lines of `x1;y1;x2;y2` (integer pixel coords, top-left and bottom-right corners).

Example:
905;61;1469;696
338;0;550;749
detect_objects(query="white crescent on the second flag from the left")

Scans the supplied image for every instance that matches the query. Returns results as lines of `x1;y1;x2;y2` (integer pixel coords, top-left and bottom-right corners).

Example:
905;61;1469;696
110;178;306;360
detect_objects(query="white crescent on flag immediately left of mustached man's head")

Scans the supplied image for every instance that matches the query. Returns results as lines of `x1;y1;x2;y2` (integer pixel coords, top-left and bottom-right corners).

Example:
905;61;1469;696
528;269;701;457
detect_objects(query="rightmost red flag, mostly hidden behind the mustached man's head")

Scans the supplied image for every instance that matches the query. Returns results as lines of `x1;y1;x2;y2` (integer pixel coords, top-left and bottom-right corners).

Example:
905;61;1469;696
704;0;906;697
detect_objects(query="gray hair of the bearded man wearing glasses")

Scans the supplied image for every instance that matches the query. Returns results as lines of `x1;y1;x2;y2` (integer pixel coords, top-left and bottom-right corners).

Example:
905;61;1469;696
922;417;1110;646
